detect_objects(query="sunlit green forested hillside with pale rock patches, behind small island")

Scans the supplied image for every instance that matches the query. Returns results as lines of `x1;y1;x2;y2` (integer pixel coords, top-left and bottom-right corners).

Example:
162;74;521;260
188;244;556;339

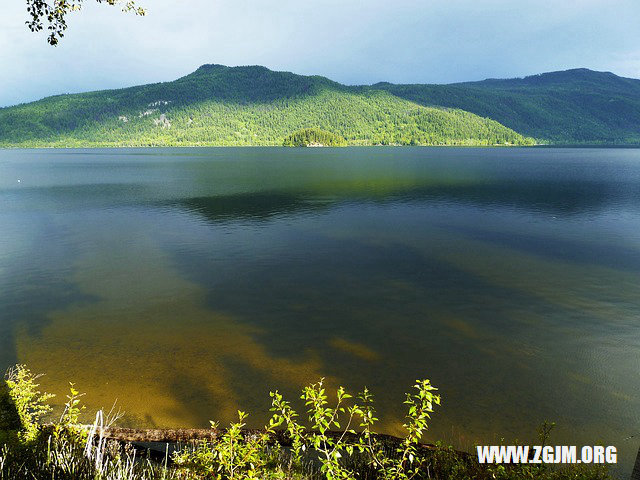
0;65;532;146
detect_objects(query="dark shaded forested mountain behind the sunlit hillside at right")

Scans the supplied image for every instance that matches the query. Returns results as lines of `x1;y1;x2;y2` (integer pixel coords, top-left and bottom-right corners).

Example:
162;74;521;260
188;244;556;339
372;69;640;144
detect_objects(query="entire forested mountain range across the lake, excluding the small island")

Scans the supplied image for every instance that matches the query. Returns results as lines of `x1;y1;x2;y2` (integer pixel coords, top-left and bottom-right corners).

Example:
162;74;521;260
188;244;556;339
0;65;640;146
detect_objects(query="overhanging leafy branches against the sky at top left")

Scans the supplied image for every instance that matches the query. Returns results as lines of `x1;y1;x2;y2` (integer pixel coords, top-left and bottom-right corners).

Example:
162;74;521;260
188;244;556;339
27;0;145;45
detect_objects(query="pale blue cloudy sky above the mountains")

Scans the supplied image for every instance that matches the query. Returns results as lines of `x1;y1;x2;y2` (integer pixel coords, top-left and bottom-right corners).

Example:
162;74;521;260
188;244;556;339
0;0;640;106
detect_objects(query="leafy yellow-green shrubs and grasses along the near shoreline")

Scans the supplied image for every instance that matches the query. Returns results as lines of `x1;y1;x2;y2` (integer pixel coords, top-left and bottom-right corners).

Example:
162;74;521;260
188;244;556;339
0;365;612;480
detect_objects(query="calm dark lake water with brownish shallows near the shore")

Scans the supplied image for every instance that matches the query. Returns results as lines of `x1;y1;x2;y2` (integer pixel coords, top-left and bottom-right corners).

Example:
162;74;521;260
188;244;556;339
0;148;640;465
